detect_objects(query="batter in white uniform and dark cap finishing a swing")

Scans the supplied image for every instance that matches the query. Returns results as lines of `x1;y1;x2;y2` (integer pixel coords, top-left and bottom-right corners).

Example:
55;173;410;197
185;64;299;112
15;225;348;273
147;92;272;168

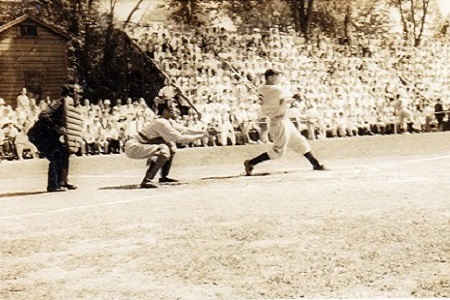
244;69;325;176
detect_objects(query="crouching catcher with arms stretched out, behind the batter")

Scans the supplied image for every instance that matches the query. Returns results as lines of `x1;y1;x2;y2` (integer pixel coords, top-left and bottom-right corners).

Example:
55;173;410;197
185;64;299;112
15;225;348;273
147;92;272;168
125;102;207;189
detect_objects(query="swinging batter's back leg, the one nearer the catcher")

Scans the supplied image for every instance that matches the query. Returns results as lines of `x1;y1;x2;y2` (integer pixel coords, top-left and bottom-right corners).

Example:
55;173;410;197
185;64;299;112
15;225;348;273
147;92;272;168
244;121;286;176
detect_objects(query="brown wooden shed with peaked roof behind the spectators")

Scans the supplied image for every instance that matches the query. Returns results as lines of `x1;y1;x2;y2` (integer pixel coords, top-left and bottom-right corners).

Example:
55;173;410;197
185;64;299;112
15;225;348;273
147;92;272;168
0;15;69;108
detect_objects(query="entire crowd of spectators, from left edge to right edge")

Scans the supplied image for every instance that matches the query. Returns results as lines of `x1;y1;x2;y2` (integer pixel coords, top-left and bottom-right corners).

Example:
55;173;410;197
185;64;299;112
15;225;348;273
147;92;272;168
0;23;450;159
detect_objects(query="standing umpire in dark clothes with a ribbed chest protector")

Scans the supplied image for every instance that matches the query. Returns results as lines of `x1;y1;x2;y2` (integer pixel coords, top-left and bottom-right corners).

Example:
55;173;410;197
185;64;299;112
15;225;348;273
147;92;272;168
28;85;83;192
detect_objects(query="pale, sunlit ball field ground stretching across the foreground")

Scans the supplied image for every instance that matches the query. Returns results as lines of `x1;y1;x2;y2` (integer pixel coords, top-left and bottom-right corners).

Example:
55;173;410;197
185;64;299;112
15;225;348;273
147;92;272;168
0;133;450;300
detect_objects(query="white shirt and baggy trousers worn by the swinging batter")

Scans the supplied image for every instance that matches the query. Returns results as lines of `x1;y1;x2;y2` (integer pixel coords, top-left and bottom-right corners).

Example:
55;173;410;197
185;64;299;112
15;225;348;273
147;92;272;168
258;84;311;159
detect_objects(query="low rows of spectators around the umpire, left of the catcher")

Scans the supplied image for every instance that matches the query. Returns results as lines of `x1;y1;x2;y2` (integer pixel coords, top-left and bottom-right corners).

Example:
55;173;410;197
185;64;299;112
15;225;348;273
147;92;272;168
0;89;155;160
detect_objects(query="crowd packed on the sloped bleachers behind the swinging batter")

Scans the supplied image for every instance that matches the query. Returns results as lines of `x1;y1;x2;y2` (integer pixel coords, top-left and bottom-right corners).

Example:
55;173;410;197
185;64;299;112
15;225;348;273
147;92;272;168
124;23;450;138
